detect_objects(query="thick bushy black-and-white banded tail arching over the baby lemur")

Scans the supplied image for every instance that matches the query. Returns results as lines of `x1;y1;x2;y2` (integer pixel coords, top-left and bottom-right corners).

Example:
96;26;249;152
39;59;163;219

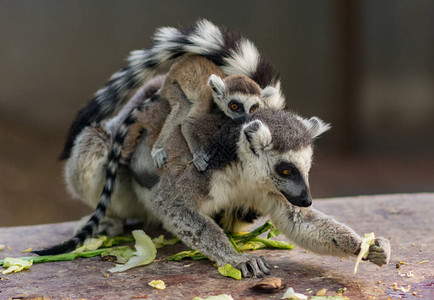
60;20;284;159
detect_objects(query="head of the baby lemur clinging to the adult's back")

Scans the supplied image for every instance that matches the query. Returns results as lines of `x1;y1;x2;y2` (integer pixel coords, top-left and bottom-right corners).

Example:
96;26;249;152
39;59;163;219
208;74;276;120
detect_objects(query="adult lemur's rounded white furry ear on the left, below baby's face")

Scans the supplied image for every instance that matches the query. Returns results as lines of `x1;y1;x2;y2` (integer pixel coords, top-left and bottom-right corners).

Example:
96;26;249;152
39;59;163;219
242;120;272;155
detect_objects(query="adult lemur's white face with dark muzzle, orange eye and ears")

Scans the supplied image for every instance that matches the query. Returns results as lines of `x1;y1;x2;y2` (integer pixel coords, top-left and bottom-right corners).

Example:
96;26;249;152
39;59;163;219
238;112;329;207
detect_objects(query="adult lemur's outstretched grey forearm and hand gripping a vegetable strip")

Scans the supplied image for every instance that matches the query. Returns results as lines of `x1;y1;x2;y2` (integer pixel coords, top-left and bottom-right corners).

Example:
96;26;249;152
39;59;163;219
270;199;390;266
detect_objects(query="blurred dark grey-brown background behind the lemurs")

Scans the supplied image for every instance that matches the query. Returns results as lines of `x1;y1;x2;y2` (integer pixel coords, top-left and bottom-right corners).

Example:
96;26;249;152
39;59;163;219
0;0;434;226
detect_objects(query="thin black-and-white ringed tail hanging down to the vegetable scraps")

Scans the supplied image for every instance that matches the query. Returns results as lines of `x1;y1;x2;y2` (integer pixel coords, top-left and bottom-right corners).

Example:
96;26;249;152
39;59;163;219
33;101;148;255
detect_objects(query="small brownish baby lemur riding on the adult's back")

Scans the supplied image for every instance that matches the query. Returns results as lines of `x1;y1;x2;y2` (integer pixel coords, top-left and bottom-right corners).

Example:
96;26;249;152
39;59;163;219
151;55;277;171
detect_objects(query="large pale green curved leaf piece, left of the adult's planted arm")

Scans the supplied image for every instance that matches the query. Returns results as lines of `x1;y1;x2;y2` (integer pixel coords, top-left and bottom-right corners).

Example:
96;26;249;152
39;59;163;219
109;230;157;273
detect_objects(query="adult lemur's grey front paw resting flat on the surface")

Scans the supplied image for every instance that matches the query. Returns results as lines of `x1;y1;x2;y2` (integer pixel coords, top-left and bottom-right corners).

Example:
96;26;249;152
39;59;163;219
229;254;271;278
